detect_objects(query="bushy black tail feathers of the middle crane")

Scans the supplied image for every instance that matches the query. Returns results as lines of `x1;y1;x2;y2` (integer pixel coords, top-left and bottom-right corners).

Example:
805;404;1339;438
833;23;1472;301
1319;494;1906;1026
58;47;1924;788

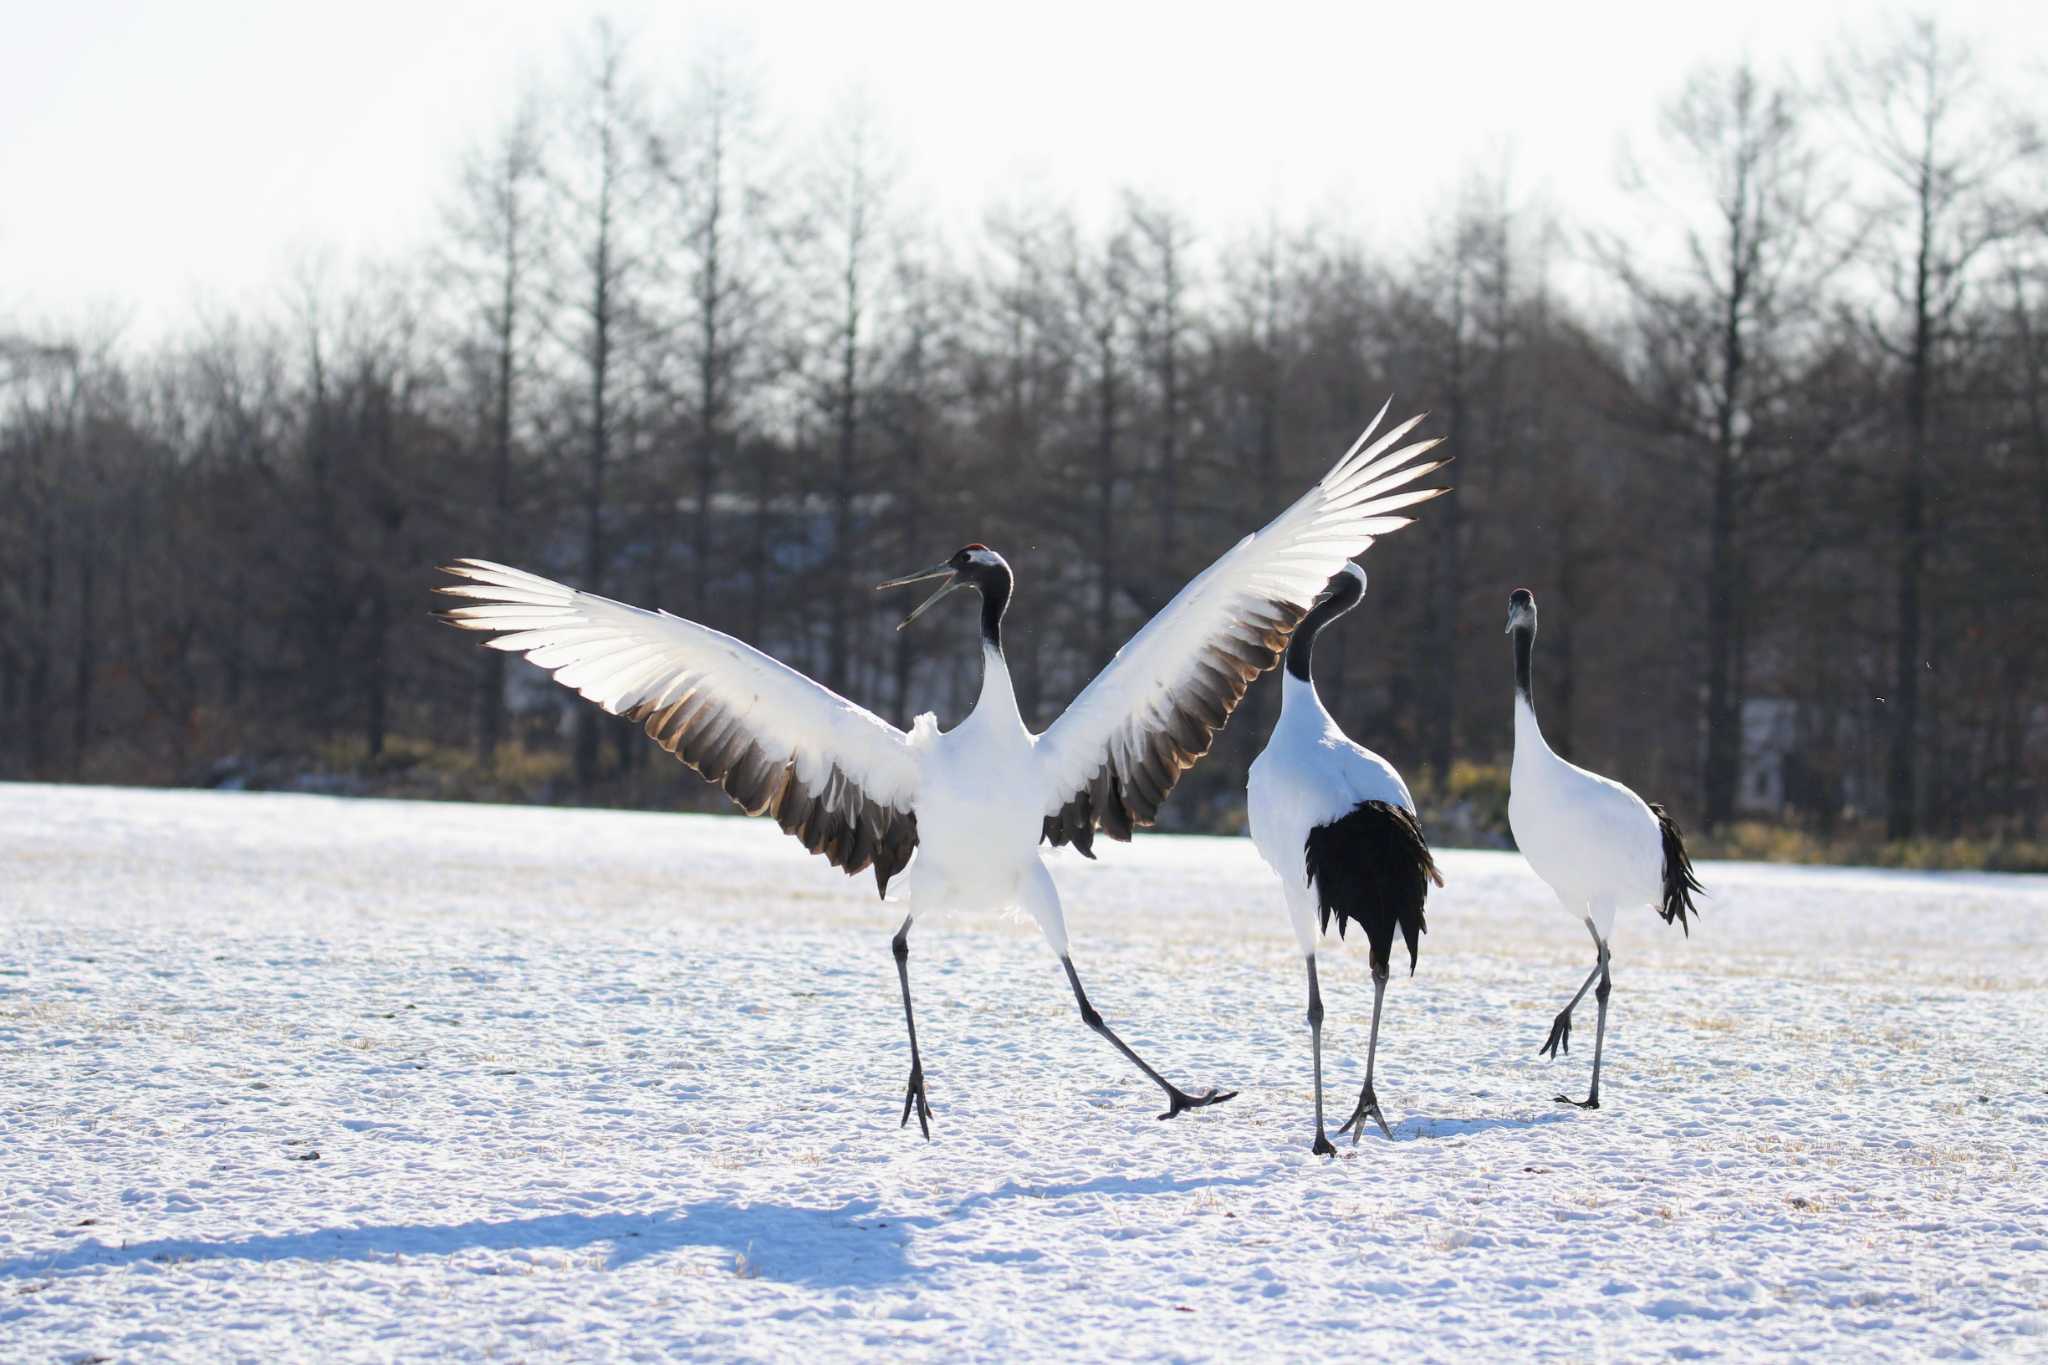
1307;800;1444;976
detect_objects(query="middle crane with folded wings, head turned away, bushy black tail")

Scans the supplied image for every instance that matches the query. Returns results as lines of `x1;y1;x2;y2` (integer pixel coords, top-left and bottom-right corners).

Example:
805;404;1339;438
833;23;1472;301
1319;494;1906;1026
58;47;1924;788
1245;563;1444;1156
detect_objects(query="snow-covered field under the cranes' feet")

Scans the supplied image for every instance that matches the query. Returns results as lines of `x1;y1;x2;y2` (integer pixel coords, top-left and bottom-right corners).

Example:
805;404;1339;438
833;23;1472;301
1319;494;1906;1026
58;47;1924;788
0;786;2048;1361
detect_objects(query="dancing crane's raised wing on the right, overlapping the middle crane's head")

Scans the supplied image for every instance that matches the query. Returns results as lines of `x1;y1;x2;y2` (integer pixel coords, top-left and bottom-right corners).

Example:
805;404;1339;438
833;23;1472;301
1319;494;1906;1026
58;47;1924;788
1038;407;1446;857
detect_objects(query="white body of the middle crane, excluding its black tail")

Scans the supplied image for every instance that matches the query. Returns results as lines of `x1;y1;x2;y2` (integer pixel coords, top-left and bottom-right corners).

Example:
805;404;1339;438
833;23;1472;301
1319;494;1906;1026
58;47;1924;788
1245;673;1415;954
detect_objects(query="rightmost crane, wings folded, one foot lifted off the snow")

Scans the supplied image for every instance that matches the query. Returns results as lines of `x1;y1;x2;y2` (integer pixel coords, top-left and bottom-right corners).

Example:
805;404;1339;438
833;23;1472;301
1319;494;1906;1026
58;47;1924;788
1507;587;1704;1109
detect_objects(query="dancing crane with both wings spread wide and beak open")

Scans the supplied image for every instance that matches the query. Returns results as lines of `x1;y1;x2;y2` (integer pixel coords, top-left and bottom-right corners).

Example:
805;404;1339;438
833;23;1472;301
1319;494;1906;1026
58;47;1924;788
440;407;1442;1138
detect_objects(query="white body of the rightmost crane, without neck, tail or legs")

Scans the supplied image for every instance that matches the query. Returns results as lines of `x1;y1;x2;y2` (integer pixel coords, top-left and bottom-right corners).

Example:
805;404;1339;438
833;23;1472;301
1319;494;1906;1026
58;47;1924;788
1507;694;1663;941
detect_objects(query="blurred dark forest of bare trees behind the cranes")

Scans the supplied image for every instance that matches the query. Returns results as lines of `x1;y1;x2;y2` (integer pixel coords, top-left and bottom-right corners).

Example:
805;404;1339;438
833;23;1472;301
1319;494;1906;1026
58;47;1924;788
0;18;2048;866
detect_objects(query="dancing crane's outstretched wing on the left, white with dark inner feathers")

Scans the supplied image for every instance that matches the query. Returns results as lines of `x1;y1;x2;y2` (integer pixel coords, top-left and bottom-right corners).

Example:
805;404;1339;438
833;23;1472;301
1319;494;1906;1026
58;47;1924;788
440;559;918;896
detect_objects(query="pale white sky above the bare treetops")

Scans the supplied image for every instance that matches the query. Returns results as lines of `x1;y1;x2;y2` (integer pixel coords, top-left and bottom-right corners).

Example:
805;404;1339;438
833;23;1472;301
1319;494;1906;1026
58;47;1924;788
0;0;2048;347
